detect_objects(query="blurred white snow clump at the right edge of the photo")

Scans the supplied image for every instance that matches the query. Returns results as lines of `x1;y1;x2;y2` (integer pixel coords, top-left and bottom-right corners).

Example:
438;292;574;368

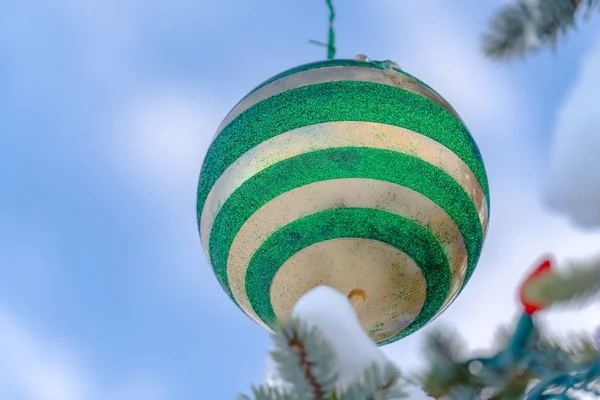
546;32;600;228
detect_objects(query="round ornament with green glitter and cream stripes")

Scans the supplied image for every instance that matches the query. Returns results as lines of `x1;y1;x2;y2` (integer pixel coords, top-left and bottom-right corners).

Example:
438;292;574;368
197;60;489;345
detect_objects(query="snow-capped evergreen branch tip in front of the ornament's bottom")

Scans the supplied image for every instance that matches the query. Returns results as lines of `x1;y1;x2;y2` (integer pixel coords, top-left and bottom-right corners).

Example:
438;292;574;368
240;287;428;400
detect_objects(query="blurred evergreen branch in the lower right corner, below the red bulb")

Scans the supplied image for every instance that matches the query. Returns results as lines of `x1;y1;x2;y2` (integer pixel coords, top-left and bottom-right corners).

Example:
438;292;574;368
417;315;600;400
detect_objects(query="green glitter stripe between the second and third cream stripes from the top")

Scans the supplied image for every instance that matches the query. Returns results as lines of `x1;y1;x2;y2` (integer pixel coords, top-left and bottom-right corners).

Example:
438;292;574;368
209;147;483;308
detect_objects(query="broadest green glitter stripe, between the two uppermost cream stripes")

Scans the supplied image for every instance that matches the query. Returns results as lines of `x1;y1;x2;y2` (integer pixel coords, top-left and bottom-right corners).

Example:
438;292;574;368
197;81;489;213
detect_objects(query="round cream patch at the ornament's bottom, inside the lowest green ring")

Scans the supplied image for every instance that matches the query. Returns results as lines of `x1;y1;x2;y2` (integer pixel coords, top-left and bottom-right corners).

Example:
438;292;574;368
270;238;427;342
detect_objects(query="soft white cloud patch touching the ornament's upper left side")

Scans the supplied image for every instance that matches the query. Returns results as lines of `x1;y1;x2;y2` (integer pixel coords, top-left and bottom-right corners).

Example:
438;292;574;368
113;88;222;198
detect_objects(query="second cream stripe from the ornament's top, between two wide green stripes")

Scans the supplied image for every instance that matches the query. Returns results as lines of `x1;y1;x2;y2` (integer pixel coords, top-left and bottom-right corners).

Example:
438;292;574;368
200;121;488;254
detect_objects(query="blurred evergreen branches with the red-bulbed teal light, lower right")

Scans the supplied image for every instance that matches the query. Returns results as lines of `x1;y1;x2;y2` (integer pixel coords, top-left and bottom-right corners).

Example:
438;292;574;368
417;260;600;400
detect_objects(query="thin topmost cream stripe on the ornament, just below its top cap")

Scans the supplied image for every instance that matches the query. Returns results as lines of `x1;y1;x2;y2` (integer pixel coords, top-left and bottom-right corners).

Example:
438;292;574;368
213;66;461;141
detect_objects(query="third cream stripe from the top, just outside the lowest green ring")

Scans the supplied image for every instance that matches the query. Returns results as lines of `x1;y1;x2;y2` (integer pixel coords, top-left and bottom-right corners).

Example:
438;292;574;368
227;178;467;326
